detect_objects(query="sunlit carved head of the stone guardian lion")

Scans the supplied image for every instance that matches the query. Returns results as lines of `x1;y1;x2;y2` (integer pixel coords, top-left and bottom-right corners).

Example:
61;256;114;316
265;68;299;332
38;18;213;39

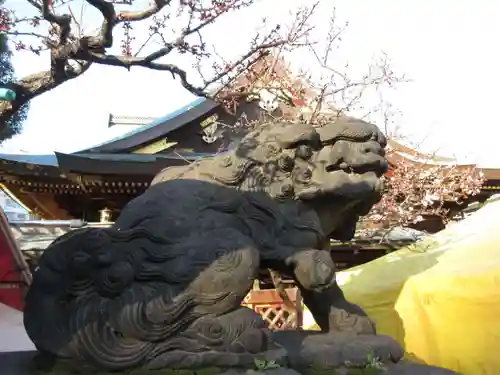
229;117;387;201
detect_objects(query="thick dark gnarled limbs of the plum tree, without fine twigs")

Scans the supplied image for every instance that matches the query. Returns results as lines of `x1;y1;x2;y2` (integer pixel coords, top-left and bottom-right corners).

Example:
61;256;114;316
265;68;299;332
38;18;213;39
0;0;181;126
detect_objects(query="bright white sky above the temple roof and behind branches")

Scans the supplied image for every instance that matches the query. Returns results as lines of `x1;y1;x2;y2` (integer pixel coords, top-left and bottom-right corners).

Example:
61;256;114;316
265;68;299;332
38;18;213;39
0;0;500;168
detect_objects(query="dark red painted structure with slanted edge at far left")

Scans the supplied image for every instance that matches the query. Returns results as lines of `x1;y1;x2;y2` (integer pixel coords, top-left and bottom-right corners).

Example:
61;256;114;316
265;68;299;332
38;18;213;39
0;209;31;311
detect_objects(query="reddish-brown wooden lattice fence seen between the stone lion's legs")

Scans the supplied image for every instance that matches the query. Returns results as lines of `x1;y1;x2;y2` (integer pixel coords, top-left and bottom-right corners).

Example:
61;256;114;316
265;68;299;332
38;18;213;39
243;288;303;331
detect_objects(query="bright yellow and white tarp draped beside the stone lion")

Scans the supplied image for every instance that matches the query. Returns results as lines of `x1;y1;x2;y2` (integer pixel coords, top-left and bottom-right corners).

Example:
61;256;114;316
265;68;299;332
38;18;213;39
330;200;500;375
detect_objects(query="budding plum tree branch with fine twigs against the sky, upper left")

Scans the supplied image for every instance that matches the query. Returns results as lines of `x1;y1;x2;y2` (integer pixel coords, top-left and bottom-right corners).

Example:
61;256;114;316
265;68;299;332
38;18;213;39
0;0;314;130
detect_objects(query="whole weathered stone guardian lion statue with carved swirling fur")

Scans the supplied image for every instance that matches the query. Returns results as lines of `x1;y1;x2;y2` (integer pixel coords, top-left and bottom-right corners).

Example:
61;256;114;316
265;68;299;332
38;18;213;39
24;118;456;371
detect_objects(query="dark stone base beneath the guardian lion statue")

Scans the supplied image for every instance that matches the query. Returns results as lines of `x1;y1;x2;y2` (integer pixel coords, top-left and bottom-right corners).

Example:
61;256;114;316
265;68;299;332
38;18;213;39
0;331;457;375
